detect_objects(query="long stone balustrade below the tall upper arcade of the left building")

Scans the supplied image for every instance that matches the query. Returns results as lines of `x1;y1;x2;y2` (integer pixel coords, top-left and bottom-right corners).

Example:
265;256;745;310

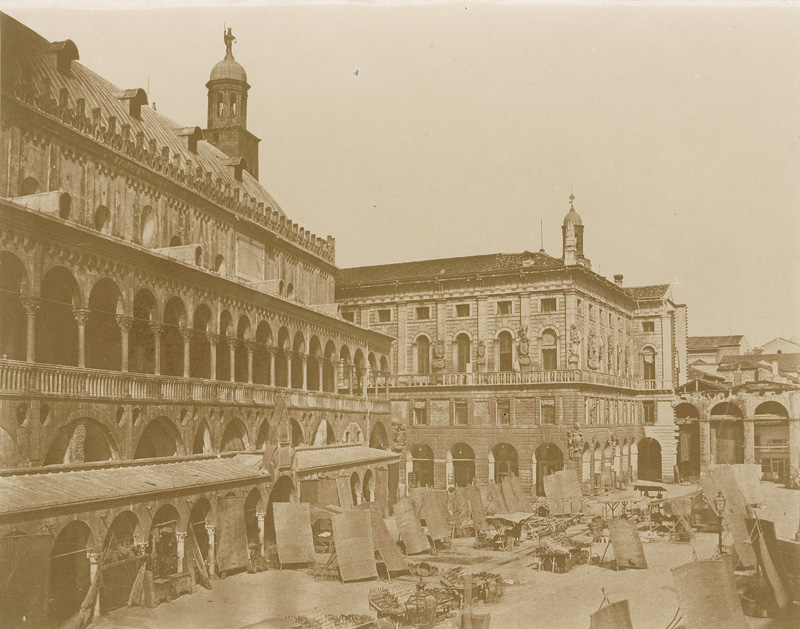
0;360;389;412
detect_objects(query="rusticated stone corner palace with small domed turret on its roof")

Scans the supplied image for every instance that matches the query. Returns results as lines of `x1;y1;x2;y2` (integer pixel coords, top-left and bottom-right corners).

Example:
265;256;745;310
336;196;687;495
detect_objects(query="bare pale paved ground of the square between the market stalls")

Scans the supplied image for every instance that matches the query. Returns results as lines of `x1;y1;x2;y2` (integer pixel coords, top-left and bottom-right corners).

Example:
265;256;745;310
96;483;800;629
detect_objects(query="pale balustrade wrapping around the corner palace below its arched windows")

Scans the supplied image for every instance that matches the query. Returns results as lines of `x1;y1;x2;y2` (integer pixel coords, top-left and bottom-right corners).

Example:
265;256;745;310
389;369;672;391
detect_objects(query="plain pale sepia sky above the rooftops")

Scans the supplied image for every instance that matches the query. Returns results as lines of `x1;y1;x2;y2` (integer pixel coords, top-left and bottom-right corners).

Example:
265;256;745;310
0;0;800;346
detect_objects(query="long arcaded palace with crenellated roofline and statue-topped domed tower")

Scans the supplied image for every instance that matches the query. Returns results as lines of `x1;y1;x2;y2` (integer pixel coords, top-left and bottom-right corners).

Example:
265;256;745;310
0;15;399;626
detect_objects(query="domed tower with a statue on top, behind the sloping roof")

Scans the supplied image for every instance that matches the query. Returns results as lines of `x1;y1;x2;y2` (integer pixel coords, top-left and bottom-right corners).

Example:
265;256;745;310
203;28;261;179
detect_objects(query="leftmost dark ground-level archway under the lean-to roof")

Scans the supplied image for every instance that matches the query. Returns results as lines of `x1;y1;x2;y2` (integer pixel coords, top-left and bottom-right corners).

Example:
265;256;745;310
50;520;94;624
